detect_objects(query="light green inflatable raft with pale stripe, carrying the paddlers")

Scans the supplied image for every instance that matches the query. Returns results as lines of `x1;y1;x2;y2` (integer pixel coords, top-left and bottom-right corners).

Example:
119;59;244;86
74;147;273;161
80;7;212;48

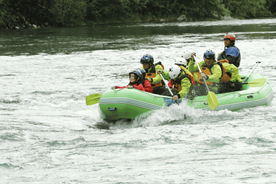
99;74;273;120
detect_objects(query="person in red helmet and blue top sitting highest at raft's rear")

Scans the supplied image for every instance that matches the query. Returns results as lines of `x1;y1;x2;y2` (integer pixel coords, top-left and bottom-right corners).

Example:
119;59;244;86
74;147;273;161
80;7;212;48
218;33;241;68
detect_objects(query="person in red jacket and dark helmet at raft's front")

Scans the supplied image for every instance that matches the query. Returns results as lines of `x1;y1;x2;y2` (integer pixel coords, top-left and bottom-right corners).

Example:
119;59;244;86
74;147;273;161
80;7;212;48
111;70;145;91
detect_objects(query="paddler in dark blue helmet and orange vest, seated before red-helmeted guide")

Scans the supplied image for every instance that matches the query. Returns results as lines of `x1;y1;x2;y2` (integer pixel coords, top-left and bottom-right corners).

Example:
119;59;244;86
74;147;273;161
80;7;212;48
188;50;222;95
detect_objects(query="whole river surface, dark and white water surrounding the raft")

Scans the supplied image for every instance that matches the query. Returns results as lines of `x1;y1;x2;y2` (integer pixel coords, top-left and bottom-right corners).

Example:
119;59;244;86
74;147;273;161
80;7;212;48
0;18;276;184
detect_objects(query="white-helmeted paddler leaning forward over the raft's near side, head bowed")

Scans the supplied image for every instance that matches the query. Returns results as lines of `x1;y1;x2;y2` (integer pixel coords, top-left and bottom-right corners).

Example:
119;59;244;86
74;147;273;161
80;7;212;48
158;65;192;100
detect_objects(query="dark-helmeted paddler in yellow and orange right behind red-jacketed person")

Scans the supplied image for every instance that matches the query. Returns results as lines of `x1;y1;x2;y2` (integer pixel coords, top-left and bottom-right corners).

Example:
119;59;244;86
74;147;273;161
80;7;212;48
140;54;168;94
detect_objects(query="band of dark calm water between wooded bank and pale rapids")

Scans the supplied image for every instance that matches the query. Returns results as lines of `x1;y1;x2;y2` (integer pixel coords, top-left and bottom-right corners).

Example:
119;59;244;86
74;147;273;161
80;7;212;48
0;19;276;56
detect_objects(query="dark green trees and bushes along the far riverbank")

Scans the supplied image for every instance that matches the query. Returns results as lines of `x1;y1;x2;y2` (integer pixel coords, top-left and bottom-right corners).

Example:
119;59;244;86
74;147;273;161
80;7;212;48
0;0;276;29
